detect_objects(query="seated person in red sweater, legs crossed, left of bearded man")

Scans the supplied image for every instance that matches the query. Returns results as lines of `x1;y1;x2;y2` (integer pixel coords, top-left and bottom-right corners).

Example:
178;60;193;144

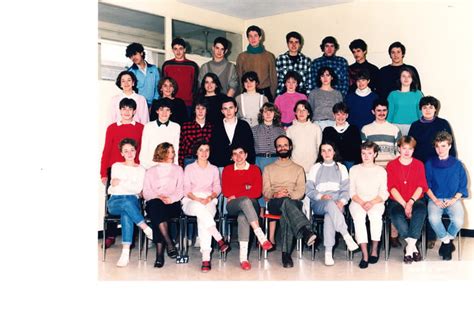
222;145;272;270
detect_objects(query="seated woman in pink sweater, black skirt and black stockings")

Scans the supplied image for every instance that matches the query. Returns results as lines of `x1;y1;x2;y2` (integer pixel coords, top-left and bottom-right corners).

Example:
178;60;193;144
143;142;183;268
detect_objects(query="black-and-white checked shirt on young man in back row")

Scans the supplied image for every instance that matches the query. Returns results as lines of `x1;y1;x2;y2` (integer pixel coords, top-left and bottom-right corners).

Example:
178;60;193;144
276;51;311;95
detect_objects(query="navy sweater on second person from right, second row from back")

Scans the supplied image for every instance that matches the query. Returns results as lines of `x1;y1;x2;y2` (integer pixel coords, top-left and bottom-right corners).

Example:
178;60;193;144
346;92;378;131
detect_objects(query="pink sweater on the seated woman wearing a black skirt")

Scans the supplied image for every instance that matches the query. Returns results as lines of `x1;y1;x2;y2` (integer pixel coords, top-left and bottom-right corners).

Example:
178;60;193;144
143;162;183;203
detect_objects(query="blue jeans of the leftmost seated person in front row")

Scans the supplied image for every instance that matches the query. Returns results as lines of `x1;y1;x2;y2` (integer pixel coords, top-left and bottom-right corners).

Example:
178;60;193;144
107;195;144;245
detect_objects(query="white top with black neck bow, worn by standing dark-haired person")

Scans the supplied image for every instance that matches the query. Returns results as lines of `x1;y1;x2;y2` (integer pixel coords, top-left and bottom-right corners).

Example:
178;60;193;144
139;121;181;169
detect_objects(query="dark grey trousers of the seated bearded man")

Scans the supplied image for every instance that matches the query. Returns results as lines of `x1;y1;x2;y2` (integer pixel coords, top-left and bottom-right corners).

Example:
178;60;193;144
268;197;311;253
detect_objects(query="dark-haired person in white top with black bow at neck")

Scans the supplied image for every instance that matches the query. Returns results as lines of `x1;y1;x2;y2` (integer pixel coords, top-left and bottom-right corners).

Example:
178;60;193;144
140;98;181;169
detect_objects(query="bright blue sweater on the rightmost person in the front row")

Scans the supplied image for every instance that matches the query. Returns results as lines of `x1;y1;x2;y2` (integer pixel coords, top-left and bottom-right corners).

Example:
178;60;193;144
425;156;468;198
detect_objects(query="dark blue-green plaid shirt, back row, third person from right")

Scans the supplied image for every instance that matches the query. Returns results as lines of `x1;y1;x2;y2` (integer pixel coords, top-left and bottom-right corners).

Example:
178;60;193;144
310;55;349;97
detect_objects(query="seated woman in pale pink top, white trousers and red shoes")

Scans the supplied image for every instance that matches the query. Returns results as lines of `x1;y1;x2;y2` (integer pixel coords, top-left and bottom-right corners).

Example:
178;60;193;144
182;140;229;272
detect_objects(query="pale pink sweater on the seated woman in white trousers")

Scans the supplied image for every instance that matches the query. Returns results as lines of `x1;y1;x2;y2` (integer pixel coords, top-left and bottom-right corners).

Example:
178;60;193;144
184;162;221;196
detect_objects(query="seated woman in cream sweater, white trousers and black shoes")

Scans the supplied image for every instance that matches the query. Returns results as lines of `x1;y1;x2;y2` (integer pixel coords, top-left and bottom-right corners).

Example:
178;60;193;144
349;141;388;269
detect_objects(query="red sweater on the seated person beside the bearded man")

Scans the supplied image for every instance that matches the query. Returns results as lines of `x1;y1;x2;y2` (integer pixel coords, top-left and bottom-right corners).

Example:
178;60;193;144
222;164;262;198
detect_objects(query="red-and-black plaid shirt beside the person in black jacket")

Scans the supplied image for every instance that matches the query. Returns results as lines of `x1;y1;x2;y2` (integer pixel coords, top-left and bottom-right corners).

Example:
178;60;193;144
178;121;212;168
